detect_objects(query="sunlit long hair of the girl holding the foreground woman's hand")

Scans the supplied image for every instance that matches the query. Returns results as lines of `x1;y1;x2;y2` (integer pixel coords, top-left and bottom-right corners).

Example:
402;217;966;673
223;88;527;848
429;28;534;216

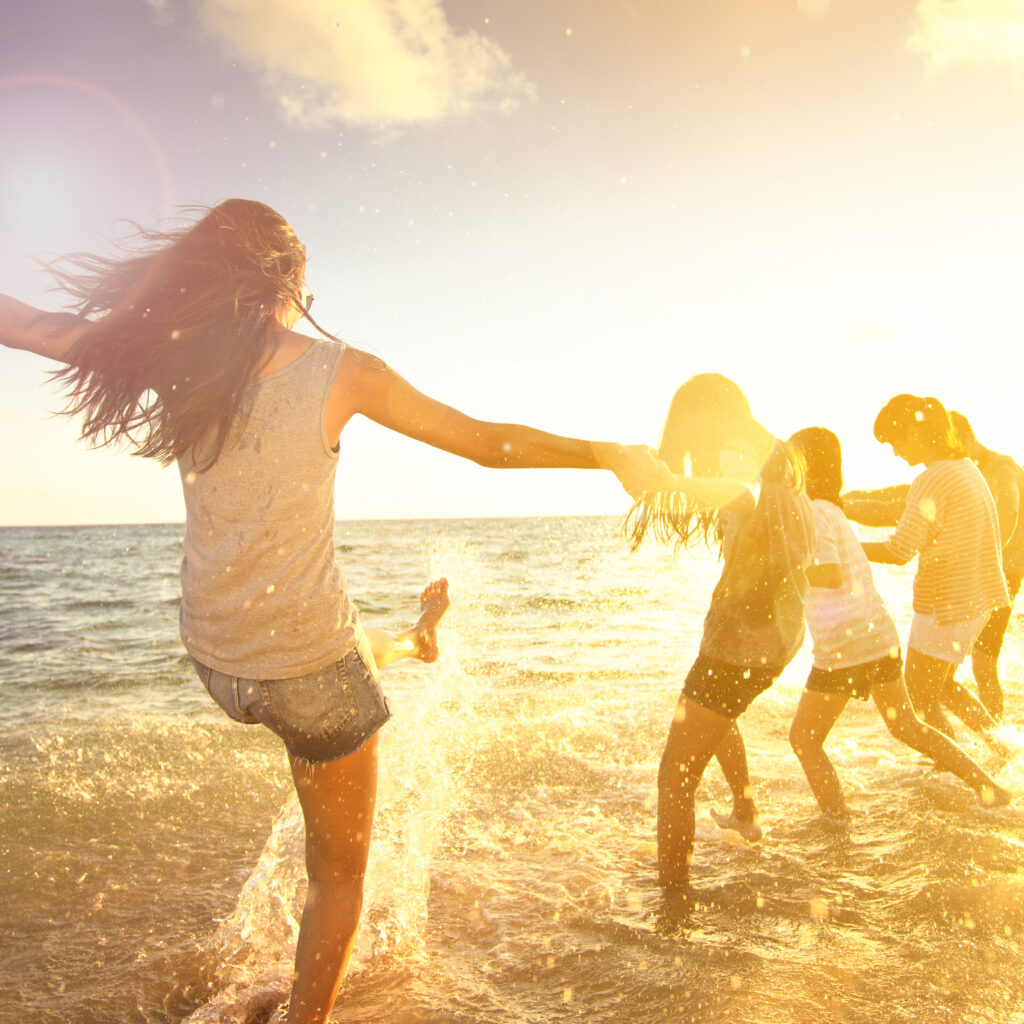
623;374;803;551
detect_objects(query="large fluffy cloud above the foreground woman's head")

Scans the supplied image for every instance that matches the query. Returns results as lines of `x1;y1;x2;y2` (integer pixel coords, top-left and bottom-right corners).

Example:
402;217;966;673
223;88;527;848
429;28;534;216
191;0;532;128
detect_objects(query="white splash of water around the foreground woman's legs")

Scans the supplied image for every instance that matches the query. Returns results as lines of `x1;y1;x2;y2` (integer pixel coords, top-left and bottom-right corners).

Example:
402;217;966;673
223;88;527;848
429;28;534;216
188;542;487;1024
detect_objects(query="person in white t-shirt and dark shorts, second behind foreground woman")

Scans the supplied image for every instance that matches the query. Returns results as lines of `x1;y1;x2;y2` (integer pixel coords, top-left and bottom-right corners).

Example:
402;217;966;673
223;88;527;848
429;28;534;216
790;427;1010;815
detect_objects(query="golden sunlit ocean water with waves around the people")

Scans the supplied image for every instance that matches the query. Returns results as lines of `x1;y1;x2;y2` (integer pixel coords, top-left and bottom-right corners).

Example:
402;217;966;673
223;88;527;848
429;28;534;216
0;518;1024;1024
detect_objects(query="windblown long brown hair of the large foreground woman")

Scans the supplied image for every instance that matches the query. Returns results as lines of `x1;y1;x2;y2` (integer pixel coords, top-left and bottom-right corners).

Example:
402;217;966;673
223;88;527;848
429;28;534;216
49;199;306;469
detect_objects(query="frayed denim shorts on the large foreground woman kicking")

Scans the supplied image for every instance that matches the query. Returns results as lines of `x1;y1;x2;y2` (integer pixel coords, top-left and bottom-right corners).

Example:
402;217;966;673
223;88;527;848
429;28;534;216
193;633;391;764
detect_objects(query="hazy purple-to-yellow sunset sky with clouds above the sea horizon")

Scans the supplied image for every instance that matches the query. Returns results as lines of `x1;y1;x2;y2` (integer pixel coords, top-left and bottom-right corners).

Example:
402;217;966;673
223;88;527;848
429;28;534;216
0;0;1024;525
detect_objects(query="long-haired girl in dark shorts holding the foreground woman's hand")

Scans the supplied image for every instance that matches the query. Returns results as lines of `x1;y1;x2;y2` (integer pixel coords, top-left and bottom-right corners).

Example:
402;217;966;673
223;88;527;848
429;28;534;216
626;374;814;888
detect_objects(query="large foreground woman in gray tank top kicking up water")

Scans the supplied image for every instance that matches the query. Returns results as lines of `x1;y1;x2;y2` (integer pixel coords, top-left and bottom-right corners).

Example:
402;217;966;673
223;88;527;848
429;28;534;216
0;199;652;1024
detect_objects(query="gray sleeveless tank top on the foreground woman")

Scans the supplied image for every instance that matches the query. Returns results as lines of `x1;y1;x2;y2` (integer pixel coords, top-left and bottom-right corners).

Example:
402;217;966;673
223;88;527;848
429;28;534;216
178;341;358;679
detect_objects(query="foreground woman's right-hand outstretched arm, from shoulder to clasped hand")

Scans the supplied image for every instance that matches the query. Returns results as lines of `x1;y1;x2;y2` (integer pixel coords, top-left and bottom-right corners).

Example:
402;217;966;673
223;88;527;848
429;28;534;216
327;349;657;494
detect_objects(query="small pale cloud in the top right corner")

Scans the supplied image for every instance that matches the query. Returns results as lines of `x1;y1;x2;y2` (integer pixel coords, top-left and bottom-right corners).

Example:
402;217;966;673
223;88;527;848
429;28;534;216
909;0;1024;79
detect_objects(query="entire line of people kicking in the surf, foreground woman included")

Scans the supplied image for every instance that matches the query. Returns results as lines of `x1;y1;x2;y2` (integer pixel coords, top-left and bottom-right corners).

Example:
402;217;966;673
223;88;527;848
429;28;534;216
0;200;1024;1024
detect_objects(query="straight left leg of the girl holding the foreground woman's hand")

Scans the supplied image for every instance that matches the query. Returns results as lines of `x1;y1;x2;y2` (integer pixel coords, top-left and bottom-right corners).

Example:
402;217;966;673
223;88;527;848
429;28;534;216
657;696;732;886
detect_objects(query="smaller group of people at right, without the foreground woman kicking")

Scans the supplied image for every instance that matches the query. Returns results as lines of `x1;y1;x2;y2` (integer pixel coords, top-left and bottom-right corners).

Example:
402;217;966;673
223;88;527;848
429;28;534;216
627;374;1024;893
